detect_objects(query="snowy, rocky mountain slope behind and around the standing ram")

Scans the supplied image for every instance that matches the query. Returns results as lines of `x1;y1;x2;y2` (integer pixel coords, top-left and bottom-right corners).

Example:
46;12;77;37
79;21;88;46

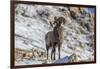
15;4;94;65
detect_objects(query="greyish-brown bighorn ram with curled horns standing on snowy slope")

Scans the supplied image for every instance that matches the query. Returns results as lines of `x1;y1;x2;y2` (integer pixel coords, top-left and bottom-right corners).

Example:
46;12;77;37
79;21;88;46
45;17;66;60
